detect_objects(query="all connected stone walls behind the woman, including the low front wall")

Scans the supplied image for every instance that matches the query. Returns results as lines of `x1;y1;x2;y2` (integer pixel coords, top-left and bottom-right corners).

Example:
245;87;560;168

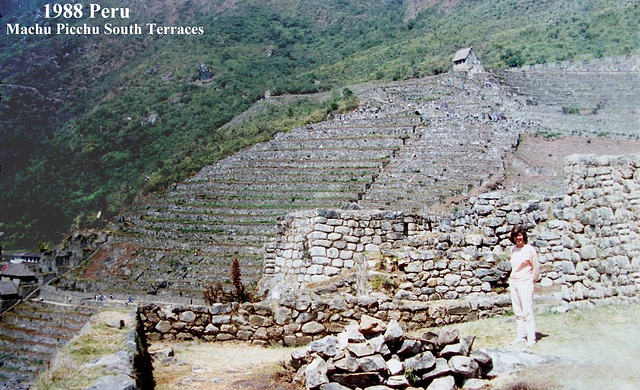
139;155;640;345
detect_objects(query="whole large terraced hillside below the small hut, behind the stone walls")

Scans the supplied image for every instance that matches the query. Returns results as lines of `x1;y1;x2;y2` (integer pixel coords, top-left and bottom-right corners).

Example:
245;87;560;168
60;55;640;299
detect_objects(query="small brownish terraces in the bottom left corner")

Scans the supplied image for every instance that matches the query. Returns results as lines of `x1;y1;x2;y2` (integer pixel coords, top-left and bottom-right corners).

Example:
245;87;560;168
0;301;95;389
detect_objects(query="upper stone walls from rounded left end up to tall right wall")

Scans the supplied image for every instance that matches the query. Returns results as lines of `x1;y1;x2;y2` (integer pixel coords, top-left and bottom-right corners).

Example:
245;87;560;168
262;192;567;301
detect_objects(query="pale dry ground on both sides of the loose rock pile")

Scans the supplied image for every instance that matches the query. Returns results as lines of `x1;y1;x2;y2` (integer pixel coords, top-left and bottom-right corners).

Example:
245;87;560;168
152;305;640;390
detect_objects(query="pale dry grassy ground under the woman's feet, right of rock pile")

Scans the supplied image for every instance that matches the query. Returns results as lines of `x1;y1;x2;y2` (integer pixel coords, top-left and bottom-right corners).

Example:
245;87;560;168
442;305;640;390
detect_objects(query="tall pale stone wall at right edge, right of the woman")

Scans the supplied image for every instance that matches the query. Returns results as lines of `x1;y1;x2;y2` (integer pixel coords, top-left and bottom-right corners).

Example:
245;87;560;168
556;155;640;301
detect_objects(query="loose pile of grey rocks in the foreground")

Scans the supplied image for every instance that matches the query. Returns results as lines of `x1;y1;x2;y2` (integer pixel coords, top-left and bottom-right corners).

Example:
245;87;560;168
290;315;492;390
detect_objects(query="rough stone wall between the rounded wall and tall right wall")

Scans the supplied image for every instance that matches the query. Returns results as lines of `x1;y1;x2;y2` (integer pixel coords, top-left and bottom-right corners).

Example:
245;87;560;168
381;192;562;301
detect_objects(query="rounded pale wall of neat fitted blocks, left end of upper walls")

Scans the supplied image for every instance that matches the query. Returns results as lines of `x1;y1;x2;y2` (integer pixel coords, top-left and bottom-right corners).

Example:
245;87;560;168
263;209;428;289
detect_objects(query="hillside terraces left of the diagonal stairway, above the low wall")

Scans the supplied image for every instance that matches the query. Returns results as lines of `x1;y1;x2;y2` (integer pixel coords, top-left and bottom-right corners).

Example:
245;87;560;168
85;120;422;297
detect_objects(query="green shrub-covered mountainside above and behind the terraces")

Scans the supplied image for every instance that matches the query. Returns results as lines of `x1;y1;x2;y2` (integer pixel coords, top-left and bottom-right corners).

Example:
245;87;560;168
0;0;640;248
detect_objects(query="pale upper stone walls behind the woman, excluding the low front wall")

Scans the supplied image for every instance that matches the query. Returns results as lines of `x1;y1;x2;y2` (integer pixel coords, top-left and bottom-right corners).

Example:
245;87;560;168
263;156;640;301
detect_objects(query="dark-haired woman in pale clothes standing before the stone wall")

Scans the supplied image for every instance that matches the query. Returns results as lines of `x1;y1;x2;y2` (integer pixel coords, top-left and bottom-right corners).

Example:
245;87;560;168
509;227;540;347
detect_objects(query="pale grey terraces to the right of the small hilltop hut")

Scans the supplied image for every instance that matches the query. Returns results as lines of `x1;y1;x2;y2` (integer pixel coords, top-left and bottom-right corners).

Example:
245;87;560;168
498;56;640;139
